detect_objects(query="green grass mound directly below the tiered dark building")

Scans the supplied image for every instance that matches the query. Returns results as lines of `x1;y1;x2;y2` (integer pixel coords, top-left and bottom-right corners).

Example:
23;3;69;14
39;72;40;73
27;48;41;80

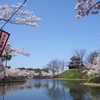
57;69;87;79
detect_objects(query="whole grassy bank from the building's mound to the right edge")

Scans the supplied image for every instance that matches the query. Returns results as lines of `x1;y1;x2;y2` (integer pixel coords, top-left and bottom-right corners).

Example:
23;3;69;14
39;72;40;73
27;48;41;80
54;69;100;87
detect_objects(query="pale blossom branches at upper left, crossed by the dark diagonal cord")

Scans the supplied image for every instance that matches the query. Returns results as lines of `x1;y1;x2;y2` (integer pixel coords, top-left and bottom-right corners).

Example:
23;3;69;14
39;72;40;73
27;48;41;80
0;3;41;27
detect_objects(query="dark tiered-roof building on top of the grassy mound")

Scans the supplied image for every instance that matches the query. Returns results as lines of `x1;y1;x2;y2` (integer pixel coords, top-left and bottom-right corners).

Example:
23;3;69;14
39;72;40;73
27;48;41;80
68;56;84;69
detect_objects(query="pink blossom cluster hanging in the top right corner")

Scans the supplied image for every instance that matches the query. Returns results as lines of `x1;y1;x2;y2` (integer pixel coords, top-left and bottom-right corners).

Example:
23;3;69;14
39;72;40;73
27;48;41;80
75;0;100;18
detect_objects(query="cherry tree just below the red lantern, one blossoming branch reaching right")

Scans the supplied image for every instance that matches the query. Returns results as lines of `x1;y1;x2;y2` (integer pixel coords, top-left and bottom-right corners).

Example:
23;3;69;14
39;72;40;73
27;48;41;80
0;44;30;78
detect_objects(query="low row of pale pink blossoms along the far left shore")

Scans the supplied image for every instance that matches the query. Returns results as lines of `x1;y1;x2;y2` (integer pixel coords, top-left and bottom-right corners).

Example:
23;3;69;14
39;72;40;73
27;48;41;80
0;68;53;79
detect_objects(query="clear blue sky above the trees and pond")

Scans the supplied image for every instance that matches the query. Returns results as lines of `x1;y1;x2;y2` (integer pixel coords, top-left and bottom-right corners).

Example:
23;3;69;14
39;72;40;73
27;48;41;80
0;0;100;69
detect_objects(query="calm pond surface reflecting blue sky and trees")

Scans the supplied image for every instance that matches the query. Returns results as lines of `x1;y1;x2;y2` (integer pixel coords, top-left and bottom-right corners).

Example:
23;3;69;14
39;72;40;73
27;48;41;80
0;79;100;100
